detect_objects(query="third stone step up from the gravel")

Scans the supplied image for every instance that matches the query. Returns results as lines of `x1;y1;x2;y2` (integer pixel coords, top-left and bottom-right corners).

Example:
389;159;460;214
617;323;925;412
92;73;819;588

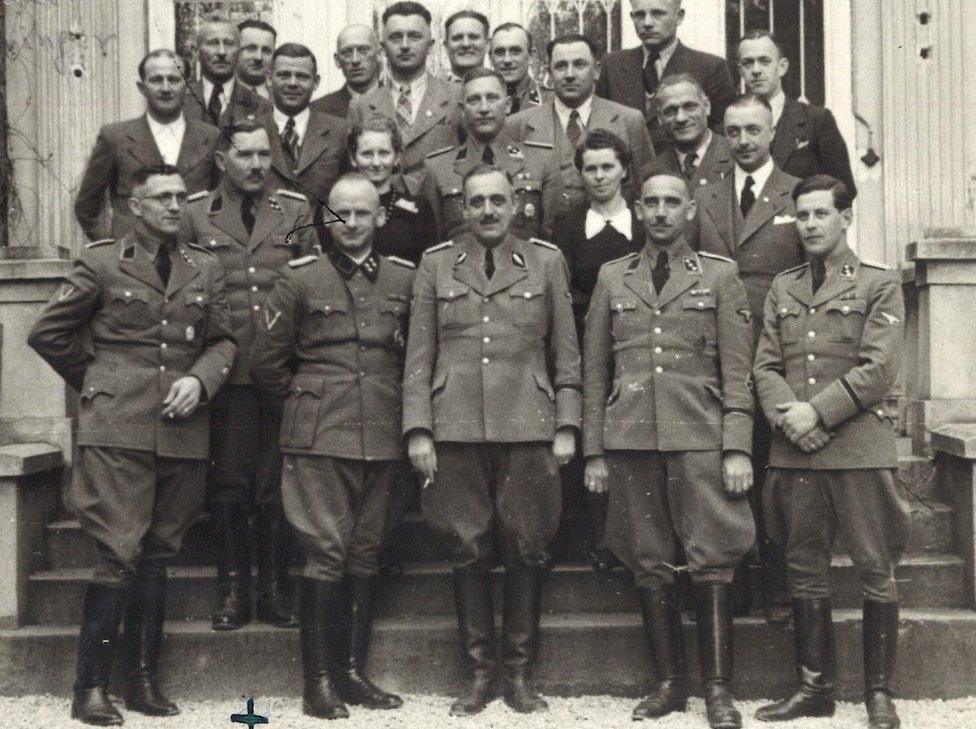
46;486;954;569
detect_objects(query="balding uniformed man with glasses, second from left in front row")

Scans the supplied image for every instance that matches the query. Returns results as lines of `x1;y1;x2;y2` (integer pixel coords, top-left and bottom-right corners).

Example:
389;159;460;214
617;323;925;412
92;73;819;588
251;173;415;719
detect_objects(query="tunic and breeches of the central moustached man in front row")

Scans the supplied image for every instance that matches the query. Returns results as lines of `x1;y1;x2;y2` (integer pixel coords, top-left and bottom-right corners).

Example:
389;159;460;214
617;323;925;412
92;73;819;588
403;234;581;566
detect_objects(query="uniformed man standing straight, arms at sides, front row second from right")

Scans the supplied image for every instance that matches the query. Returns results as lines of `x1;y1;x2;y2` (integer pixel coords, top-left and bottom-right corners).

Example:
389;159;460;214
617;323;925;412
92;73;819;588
583;168;756;728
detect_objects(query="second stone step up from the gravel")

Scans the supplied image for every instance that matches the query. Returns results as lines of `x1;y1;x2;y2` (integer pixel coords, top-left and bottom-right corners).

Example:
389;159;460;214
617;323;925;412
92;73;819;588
27;555;967;625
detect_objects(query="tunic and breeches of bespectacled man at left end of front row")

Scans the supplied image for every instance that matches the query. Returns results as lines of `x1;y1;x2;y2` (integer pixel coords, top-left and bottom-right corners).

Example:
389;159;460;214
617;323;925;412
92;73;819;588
28;233;237;583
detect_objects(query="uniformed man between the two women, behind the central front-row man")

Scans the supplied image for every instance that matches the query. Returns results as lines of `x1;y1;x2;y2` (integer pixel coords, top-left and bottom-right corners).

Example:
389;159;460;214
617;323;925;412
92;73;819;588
421;68;556;240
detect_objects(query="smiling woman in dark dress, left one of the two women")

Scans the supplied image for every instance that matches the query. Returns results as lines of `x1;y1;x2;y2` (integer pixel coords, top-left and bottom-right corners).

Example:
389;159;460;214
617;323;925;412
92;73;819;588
316;116;438;263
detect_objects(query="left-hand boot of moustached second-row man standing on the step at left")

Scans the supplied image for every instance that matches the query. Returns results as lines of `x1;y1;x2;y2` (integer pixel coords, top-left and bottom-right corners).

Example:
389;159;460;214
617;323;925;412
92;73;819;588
210;503;251;630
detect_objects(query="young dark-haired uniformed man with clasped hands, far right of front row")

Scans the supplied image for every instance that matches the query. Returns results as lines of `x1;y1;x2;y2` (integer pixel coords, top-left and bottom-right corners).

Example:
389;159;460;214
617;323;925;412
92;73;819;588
754;175;911;729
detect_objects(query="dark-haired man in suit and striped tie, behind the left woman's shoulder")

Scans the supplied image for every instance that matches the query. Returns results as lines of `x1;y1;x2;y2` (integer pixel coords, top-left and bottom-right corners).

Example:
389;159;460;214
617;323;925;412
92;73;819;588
264;43;349;209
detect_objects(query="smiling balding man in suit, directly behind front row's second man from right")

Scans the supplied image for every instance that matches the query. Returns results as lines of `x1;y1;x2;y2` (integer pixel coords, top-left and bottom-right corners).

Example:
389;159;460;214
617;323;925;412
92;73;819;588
655;73;735;194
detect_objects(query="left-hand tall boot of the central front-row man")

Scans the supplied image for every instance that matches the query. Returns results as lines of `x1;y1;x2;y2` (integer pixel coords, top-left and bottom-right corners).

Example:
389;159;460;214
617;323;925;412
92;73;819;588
451;566;496;716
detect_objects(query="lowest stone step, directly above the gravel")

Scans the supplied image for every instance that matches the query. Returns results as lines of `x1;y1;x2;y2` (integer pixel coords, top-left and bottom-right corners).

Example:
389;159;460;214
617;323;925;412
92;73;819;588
0;609;976;704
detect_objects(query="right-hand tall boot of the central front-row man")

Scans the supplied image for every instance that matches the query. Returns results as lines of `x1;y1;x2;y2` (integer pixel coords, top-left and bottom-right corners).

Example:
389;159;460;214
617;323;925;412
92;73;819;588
502;559;549;714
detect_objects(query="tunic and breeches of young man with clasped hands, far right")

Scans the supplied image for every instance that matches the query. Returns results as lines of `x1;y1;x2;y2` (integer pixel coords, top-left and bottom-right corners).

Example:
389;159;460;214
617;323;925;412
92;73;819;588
754;250;911;602
